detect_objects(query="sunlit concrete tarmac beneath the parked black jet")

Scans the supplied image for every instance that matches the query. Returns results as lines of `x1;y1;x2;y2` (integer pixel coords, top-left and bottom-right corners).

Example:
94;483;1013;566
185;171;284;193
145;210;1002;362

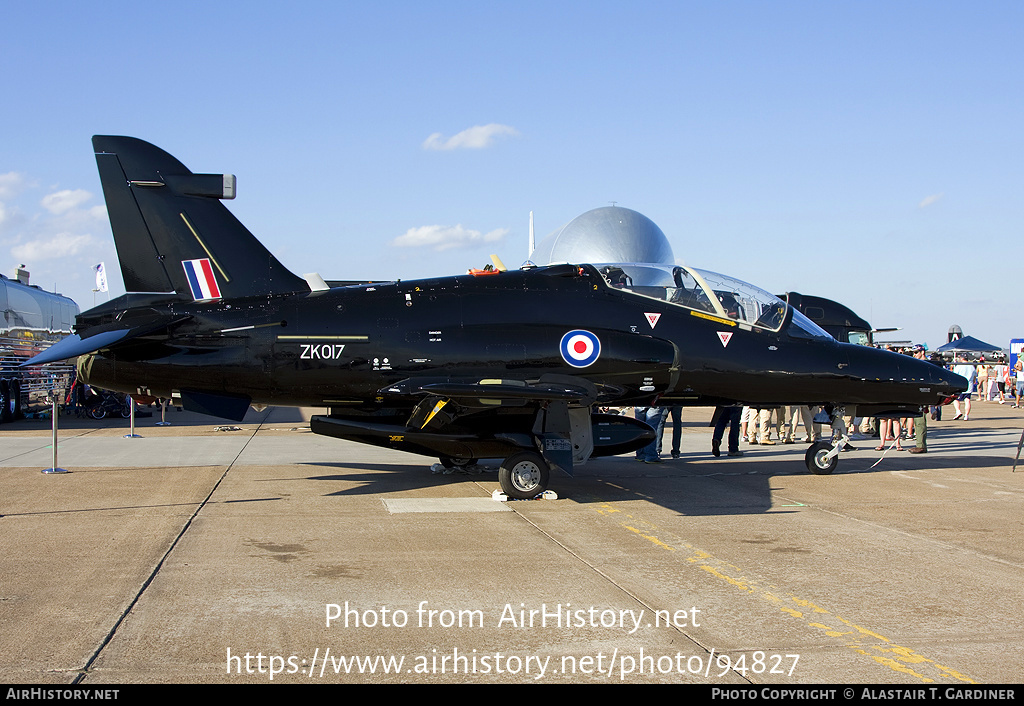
0;403;1024;689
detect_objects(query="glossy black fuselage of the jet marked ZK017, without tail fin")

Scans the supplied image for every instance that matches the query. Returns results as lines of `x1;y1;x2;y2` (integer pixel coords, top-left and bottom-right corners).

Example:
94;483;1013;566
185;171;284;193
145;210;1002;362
82;260;955;416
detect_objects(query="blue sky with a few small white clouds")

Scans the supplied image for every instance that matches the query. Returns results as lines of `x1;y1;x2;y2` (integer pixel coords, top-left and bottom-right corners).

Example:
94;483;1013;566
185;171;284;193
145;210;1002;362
0;0;1024;347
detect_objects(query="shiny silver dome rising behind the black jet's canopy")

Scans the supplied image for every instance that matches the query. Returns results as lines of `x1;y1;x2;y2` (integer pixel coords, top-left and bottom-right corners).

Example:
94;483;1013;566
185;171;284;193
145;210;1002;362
529;206;675;264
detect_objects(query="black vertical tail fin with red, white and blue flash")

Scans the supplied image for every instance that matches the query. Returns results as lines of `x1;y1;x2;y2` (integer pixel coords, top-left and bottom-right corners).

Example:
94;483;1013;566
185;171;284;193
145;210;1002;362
92;135;308;299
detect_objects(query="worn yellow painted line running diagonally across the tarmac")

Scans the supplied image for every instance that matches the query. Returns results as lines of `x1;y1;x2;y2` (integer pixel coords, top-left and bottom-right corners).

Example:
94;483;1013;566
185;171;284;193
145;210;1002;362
595;495;978;683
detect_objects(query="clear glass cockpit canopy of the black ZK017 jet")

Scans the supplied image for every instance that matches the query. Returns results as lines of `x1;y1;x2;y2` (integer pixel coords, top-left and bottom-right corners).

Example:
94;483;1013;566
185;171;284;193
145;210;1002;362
594;262;831;338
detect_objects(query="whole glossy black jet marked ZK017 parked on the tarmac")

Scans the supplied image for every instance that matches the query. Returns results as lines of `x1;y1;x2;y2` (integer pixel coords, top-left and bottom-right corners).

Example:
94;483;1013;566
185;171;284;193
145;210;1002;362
30;136;966;498
